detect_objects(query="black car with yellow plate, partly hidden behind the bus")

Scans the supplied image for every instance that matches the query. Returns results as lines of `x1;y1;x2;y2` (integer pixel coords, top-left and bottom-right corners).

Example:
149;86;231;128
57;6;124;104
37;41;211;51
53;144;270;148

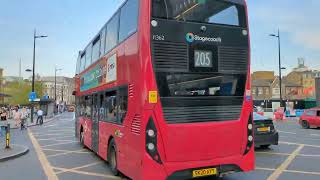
253;112;279;148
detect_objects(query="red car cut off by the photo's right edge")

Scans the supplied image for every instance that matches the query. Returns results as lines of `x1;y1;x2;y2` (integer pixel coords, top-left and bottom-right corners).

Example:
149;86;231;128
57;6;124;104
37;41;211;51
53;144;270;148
299;108;320;129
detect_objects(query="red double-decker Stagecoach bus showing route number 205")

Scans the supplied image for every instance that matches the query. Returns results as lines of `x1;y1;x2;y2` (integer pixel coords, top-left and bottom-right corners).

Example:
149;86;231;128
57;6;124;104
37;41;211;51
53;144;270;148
75;0;254;179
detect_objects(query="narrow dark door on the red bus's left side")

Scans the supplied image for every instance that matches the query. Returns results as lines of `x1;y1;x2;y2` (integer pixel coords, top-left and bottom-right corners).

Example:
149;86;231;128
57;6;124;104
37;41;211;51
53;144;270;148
92;94;100;152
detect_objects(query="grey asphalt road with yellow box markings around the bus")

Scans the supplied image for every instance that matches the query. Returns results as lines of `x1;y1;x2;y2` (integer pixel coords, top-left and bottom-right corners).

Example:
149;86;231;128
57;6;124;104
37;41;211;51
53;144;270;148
0;113;320;180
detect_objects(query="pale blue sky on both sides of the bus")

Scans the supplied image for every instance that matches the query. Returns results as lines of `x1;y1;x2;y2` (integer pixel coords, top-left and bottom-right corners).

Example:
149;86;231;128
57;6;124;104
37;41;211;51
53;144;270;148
0;0;320;77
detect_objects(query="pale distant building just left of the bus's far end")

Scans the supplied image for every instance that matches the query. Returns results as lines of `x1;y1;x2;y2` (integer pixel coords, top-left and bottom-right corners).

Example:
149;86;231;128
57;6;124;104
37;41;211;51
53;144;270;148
41;76;75;105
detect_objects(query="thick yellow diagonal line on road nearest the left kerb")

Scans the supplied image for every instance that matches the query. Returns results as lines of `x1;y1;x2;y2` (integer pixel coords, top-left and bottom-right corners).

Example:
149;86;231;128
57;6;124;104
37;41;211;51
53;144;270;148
28;129;58;180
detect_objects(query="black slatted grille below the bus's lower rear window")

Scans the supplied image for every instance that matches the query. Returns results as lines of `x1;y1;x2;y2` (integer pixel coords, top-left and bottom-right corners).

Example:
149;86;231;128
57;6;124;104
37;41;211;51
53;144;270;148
163;105;242;124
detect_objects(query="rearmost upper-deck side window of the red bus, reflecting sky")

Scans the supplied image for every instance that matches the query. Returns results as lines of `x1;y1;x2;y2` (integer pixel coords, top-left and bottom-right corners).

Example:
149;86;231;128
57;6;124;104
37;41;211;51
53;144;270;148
119;0;139;42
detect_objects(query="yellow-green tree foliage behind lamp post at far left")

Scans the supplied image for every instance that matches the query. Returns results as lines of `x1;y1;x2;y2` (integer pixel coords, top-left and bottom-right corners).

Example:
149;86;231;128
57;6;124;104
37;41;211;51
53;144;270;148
4;81;43;105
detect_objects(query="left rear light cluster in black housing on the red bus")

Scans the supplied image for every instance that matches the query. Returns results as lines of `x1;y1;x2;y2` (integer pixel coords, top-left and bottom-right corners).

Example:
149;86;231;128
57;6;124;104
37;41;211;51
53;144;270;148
145;117;162;164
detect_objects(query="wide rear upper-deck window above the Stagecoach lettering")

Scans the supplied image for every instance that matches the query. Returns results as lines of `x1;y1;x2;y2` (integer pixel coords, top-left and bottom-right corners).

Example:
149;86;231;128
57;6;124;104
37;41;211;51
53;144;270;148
152;0;246;27
